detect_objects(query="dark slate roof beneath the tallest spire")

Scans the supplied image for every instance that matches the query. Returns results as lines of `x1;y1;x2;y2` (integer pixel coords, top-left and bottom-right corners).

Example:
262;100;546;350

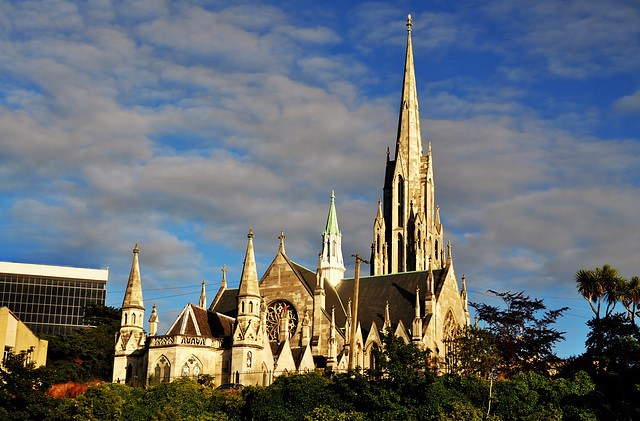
336;269;446;336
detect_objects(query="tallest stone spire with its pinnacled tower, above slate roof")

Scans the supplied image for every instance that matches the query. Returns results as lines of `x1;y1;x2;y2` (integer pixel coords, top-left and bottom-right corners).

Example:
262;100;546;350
371;15;445;275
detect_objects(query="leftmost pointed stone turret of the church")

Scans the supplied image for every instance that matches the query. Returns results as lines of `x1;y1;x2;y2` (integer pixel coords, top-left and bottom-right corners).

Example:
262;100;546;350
113;244;146;383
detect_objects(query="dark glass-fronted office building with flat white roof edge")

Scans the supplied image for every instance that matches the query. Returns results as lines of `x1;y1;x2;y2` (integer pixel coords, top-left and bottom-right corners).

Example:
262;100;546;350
0;262;109;335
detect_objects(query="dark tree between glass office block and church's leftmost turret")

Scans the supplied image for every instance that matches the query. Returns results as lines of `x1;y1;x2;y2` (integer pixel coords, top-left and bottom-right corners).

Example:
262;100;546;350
41;303;120;383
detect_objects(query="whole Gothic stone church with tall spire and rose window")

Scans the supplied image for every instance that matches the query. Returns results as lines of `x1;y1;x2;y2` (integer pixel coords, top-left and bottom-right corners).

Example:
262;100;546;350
113;17;469;385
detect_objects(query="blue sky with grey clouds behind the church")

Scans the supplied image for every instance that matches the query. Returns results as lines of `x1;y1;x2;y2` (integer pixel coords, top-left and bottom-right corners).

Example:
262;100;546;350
0;0;640;356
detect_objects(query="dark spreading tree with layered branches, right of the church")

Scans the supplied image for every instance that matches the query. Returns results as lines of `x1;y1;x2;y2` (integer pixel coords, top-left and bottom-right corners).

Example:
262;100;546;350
470;290;568;377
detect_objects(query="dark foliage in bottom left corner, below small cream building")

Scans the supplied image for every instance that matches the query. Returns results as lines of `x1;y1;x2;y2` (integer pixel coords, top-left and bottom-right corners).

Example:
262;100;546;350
0;352;55;420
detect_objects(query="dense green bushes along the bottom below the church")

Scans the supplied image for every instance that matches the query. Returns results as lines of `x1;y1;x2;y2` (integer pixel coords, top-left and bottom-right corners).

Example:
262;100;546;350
0;372;606;421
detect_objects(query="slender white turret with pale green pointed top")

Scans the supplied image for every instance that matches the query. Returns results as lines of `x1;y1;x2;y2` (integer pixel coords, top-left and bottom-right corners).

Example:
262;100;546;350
320;191;345;286
